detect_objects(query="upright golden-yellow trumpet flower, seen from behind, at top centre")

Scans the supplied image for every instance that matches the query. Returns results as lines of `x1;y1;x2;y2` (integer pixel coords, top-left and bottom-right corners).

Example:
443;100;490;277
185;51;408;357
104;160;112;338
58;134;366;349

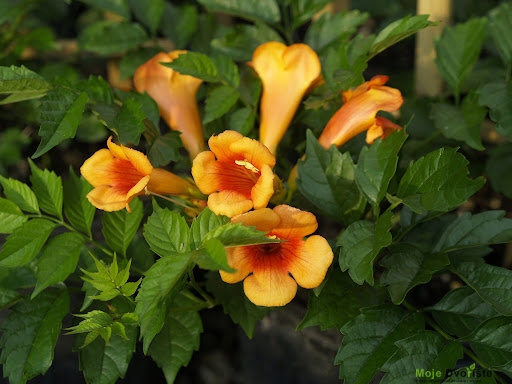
249;41;322;154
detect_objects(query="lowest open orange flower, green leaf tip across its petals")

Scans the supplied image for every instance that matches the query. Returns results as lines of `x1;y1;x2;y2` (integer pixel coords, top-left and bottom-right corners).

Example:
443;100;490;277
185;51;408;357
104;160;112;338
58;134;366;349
220;205;333;307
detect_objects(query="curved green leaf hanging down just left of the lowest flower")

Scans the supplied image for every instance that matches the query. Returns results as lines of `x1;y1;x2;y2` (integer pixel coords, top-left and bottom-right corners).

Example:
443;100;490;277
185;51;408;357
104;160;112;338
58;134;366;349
135;253;190;353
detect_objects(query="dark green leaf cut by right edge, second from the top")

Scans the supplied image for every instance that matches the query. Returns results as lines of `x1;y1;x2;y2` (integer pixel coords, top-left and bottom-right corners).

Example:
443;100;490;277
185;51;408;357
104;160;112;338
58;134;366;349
477;80;512;139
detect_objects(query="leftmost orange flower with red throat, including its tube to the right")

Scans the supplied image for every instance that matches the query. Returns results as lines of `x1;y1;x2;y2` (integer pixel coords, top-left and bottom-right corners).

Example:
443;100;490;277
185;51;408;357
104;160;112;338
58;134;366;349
80;136;197;211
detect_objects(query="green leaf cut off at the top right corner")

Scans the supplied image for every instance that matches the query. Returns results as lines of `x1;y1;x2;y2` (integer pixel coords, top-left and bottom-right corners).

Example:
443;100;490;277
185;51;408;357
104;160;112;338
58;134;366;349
488;3;512;67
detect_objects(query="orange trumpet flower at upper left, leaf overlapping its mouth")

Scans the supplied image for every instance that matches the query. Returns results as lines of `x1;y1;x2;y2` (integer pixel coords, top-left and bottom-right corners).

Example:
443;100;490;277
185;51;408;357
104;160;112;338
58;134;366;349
133;50;205;159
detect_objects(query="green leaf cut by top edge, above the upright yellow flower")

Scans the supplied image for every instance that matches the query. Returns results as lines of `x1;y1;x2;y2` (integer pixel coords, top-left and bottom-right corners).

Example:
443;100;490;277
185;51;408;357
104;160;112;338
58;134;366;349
199;0;281;23
